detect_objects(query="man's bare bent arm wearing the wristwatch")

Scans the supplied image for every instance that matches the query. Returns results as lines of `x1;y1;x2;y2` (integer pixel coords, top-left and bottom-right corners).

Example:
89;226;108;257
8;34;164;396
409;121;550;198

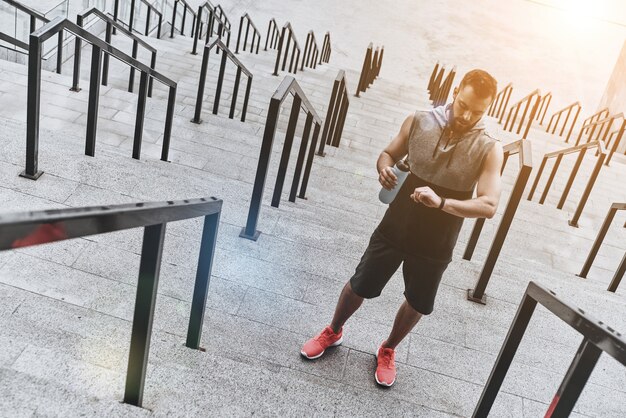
411;142;504;219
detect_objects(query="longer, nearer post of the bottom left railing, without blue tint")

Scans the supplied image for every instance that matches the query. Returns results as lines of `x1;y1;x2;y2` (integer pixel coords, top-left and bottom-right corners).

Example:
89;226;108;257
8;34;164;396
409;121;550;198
124;224;166;406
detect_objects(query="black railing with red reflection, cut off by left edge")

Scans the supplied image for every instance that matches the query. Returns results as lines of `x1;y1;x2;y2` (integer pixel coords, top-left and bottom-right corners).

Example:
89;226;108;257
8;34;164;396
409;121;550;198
0;197;222;406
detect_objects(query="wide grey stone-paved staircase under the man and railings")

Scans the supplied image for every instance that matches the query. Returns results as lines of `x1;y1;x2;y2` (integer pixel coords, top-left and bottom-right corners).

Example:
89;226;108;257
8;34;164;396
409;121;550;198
0;8;626;417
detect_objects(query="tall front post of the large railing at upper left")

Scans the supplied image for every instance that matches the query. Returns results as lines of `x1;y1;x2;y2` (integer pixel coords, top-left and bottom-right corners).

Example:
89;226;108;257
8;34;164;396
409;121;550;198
20;35;43;180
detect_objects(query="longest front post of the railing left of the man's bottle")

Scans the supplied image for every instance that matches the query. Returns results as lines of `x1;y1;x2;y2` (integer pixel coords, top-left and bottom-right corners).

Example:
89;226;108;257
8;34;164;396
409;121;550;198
239;98;280;241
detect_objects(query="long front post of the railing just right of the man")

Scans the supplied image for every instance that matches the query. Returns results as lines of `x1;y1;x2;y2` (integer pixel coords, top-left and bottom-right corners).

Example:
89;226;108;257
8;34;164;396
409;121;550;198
467;150;532;304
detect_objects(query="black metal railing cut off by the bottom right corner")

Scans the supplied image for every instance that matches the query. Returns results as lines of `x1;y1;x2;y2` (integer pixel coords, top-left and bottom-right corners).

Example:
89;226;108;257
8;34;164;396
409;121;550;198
472;281;626;418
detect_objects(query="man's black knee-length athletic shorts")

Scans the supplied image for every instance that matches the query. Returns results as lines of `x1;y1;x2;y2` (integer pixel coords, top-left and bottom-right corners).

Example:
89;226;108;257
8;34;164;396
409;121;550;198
350;229;448;315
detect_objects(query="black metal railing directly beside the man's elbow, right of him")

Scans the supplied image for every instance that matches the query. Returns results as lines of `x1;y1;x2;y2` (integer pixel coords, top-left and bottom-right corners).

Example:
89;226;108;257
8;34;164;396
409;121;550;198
463;139;533;305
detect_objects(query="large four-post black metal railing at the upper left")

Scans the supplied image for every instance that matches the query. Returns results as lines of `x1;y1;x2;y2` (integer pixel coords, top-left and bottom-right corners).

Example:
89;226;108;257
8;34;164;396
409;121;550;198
20;17;177;180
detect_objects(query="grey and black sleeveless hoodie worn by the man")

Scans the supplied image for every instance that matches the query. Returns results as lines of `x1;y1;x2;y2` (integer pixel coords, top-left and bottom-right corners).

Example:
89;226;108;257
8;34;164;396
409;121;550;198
377;105;495;264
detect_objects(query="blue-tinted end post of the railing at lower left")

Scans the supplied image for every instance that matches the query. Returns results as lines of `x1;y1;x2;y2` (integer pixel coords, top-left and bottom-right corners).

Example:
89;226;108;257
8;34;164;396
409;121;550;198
185;212;220;350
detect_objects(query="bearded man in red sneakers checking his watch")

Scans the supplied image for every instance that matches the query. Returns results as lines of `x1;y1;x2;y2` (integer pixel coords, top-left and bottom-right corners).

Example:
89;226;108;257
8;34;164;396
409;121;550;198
301;70;503;386
